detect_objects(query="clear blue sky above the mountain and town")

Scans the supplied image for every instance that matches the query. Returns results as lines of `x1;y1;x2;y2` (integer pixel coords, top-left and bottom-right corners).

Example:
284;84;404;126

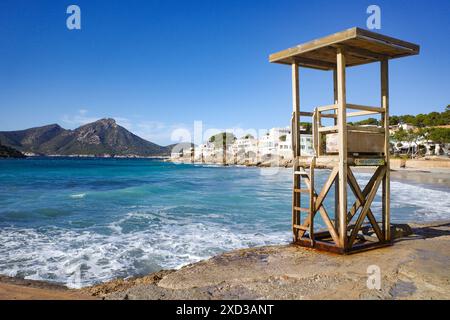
0;0;450;144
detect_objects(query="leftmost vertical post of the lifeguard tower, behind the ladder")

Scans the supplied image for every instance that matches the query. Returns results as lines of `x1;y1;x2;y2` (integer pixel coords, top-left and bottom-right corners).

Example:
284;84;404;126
291;63;302;242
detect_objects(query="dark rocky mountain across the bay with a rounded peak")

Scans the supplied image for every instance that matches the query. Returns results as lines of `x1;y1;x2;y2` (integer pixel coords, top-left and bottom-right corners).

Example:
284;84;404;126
0;119;171;156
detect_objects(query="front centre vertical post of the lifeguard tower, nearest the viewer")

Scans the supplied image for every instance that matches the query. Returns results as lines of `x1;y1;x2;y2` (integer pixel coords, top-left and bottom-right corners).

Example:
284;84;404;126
337;48;347;249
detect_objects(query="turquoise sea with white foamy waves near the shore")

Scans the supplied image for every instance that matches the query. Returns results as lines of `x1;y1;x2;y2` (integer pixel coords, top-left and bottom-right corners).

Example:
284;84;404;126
0;158;450;287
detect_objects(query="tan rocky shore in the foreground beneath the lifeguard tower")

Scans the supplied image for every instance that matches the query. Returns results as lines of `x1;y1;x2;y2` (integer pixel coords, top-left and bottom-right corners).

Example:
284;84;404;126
0;221;450;300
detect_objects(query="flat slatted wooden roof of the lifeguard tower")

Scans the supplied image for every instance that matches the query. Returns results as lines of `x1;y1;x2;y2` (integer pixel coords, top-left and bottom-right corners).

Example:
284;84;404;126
269;27;420;70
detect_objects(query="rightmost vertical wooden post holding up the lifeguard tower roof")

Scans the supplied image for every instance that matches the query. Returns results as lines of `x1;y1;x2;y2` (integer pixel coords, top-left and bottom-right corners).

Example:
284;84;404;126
381;59;391;241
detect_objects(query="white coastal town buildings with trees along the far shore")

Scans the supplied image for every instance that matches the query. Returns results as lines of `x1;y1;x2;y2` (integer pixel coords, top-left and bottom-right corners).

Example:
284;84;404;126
170;119;450;166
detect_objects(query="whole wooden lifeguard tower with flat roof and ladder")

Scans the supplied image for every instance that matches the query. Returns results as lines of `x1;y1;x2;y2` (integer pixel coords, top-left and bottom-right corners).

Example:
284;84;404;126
269;28;419;254
